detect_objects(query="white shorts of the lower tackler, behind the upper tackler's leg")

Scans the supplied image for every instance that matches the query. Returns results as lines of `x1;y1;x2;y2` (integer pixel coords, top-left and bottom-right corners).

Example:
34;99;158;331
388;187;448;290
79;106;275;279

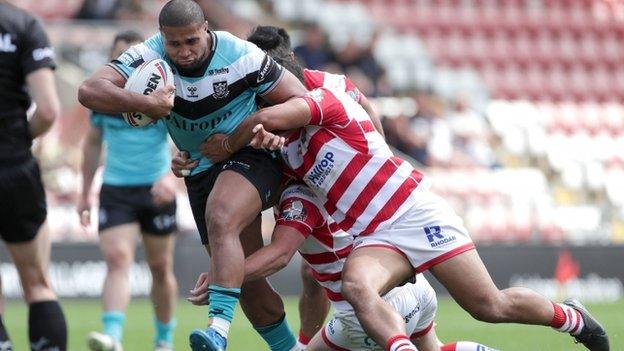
321;275;438;351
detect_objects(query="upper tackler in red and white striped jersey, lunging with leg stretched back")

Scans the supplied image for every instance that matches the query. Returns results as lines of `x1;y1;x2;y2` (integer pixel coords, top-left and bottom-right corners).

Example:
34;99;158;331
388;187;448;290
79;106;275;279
197;32;609;351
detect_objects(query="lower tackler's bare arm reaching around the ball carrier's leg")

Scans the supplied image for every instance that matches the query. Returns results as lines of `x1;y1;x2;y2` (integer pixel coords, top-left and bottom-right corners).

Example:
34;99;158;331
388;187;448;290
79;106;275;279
245;225;305;282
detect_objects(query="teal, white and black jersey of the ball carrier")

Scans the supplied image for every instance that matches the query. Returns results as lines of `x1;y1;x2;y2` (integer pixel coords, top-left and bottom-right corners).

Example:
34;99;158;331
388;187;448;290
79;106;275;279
109;31;284;175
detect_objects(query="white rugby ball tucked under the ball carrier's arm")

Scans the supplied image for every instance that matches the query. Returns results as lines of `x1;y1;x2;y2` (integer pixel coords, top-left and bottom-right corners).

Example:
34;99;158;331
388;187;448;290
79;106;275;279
122;59;173;128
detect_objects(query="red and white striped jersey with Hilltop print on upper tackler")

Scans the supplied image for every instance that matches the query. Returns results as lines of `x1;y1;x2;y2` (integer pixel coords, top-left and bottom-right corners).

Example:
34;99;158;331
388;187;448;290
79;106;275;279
282;88;428;236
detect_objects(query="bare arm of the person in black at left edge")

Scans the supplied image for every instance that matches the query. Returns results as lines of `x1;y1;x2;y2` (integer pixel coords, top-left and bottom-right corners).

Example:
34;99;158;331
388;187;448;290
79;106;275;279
26;68;61;139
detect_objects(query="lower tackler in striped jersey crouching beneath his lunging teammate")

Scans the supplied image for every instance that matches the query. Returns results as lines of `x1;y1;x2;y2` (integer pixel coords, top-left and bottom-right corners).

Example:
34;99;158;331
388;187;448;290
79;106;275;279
189;184;500;351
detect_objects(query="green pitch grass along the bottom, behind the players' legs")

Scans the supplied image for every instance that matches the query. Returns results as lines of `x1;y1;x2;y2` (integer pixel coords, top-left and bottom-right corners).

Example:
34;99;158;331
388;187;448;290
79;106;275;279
4;298;624;351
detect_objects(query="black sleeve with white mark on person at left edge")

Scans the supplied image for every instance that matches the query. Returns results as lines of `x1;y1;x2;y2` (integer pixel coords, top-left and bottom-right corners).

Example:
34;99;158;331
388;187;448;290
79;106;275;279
19;18;56;75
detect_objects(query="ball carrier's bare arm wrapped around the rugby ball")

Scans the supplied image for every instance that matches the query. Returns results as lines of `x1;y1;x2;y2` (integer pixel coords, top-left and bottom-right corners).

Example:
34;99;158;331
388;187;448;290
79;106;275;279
78;65;175;118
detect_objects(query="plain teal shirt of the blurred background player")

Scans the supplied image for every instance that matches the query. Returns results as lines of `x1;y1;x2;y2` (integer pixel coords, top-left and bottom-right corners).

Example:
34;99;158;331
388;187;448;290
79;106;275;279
91;112;171;186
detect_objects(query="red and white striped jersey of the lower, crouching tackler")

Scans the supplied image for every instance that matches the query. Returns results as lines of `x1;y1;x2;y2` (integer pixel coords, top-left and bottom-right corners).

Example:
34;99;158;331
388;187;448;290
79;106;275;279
275;184;353;310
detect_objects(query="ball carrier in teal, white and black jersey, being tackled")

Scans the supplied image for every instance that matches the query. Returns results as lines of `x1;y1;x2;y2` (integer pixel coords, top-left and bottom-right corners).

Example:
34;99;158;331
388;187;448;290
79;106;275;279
79;0;306;350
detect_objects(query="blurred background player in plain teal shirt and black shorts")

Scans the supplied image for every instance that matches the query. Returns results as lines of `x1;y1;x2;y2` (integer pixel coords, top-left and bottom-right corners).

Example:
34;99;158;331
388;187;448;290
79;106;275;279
78;31;178;351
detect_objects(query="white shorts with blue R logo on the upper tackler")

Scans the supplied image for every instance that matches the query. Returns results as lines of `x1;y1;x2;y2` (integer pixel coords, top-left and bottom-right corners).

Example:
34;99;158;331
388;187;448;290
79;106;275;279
353;191;475;273
